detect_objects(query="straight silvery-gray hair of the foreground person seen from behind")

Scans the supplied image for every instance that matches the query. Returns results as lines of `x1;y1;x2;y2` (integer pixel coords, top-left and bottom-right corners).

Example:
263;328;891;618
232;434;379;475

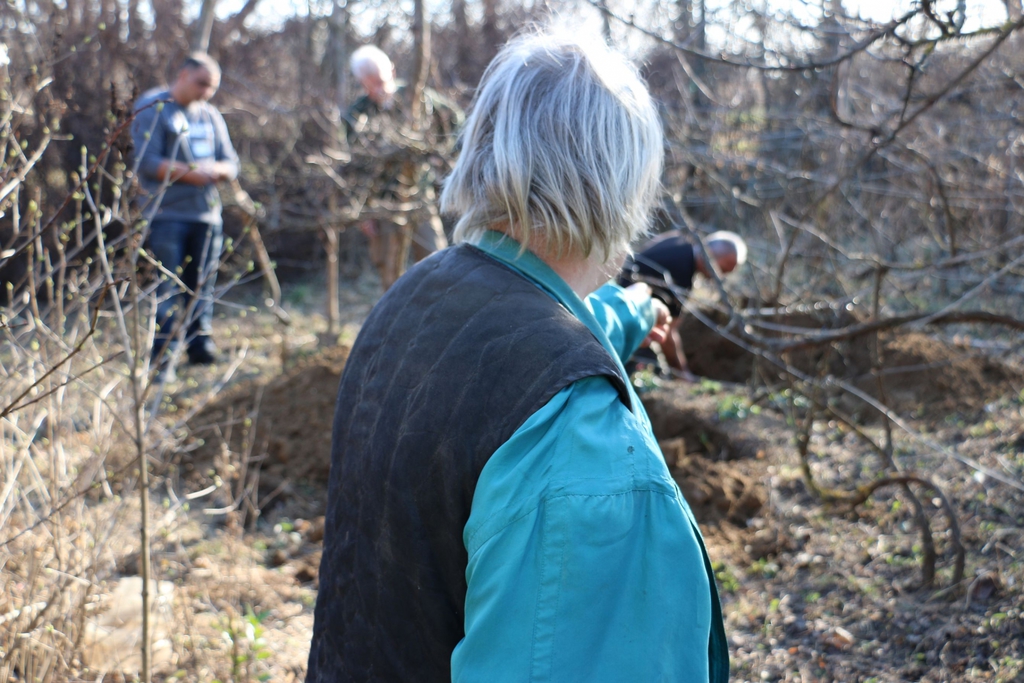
441;29;665;261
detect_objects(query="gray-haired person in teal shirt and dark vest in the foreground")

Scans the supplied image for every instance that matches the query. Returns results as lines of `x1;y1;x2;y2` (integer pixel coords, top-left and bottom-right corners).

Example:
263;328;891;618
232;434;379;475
306;35;728;683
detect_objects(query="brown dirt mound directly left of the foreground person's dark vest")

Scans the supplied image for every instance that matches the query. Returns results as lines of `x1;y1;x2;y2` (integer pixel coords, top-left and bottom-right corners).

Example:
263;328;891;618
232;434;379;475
183;346;348;498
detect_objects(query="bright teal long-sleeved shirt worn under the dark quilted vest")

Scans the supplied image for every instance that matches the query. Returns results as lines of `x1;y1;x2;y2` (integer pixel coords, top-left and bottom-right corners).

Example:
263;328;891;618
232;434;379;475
452;232;728;683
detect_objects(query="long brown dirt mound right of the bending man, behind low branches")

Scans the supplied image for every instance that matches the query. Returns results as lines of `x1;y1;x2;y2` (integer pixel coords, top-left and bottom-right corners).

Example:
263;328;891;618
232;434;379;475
681;316;1024;418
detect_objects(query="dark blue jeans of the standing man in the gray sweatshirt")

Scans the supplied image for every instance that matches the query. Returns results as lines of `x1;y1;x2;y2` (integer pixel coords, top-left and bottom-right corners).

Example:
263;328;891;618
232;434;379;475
148;218;224;358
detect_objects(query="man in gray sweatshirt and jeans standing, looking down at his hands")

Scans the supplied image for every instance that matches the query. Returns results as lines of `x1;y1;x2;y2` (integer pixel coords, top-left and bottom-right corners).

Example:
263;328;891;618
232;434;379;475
132;53;239;365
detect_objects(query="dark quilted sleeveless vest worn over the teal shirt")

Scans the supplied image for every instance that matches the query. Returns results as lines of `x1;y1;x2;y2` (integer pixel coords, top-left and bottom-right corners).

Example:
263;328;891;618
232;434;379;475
306;245;630;683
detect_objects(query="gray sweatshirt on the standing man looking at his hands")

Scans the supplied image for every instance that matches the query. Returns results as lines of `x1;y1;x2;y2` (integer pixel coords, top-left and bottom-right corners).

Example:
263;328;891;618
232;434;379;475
131;89;239;224
